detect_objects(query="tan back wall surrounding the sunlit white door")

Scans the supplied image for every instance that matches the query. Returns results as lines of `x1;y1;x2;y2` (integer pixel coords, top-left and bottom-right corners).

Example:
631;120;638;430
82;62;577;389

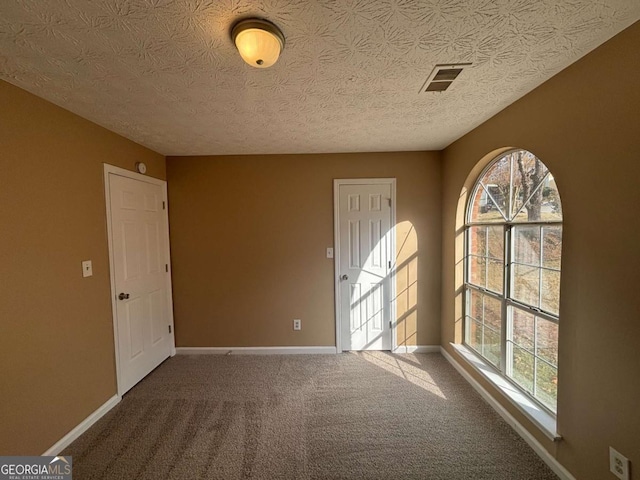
167;152;441;347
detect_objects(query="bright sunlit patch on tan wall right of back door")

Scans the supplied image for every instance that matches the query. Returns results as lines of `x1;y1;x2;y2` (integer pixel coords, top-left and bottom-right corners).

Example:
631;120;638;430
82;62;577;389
393;221;418;347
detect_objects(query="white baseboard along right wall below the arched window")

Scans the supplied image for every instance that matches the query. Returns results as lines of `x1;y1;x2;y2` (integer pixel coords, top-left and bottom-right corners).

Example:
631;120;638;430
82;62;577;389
440;347;576;480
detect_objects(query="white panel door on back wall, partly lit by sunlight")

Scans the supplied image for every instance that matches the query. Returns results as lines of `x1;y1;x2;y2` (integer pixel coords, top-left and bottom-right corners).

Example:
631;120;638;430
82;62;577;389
336;180;393;350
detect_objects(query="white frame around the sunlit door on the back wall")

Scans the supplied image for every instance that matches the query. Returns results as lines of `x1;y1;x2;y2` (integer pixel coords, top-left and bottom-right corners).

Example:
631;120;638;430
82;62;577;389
333;178;398;353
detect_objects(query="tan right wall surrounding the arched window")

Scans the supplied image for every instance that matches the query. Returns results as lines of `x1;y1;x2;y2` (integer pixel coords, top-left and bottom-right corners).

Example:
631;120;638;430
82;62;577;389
442;23;640;480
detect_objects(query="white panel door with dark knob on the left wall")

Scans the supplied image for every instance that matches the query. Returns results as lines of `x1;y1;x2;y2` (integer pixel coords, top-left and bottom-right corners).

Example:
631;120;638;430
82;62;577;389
106;167;174;394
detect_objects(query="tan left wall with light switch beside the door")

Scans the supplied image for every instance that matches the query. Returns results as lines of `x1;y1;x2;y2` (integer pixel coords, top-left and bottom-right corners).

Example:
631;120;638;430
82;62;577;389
0;81;165;455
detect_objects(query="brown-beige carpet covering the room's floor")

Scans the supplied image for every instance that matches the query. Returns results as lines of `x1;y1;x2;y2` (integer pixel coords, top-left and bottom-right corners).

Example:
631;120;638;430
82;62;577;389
64;352;557;480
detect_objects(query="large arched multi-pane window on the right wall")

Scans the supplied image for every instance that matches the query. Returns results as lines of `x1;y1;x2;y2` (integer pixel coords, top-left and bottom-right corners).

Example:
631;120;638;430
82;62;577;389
464;150;562;413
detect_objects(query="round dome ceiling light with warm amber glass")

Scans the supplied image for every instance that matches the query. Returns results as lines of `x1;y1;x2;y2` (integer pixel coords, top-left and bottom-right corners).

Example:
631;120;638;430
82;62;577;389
231;18;284;68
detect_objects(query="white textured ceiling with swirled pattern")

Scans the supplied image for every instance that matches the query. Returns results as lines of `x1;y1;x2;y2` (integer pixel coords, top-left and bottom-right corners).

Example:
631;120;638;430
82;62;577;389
0;0;640;155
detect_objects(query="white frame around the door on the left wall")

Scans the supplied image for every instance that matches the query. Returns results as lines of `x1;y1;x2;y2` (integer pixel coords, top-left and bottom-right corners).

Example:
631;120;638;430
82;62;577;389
103;163;176;397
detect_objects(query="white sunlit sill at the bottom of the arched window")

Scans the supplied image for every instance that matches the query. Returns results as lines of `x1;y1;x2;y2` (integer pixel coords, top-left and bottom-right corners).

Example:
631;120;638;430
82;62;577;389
451;343;562;441
